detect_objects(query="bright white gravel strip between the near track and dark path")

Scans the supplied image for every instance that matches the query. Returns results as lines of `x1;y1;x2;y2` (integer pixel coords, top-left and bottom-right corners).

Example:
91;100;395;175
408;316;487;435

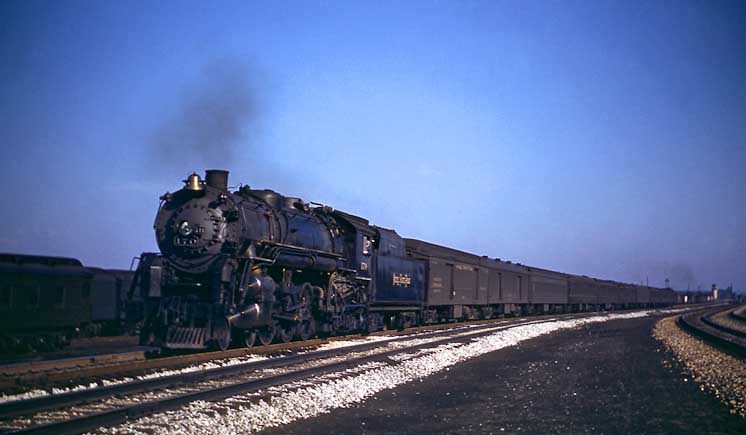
91;311;654;435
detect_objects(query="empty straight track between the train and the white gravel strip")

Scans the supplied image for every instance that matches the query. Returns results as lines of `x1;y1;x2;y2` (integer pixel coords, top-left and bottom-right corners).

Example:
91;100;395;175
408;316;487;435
0;316;564;435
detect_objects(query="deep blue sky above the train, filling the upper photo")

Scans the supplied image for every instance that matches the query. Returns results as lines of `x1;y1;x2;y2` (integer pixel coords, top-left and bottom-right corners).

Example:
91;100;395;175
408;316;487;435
0;0;746;288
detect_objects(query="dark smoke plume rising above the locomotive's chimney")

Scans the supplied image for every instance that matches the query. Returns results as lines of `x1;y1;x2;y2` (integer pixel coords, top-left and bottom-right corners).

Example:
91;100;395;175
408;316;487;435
153;60;260;172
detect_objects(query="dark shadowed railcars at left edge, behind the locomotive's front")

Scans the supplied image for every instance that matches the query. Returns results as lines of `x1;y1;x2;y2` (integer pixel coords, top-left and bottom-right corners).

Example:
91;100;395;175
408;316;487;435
0;254;134;355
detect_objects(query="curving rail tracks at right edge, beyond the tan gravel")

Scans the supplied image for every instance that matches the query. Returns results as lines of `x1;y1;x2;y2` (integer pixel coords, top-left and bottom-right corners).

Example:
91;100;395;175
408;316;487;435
677;306;746;358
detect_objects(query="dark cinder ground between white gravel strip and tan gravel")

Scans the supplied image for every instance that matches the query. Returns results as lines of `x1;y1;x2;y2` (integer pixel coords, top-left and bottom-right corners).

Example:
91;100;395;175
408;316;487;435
263;317;746;434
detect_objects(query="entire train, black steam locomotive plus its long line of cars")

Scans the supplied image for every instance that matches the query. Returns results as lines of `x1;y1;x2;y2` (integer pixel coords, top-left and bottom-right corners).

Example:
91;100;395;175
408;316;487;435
128;170;676;349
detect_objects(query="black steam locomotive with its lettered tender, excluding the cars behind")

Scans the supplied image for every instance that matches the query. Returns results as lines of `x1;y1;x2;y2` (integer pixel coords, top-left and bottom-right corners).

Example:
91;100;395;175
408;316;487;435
133;170;424;349
